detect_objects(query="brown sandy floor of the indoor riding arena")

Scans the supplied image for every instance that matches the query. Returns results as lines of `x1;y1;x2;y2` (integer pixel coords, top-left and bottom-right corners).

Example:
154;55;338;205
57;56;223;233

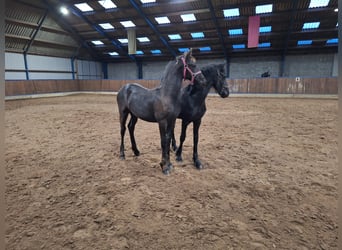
5;95;338;250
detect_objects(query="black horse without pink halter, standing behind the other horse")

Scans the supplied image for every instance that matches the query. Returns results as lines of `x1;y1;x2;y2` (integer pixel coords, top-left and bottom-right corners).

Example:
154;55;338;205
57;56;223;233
172;64;229;169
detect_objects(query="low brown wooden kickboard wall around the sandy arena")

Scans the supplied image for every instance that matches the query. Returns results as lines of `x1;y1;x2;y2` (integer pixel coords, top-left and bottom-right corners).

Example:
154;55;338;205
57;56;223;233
5;77;338;96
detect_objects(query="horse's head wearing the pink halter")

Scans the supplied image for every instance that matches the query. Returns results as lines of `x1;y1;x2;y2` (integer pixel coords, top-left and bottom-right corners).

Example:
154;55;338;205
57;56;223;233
177;49;206;85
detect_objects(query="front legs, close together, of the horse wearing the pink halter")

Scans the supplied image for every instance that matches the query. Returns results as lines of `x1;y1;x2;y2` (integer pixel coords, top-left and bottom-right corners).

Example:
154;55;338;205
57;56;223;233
159;120;173;175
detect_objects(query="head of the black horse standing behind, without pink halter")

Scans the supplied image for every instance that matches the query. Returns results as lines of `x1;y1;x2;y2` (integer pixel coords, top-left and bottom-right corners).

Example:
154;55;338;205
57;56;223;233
201;64;229;98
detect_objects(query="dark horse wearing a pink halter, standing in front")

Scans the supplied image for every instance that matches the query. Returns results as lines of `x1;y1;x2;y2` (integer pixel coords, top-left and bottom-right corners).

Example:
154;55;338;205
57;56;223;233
117;50;205;174
